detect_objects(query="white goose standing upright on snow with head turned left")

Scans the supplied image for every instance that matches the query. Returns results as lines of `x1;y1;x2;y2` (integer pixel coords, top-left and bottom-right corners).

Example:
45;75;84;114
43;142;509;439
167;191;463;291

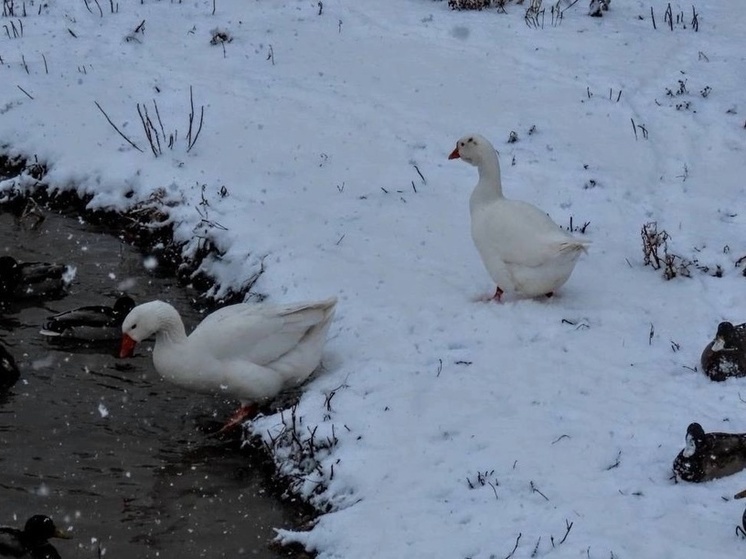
448;134;590;301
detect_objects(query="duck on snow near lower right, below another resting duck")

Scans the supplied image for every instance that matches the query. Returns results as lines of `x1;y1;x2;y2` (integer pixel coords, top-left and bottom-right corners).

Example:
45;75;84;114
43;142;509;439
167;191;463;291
673;423;746;483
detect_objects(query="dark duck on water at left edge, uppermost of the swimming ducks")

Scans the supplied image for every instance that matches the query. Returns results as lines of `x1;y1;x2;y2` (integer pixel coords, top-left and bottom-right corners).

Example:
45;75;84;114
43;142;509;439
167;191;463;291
0;256;75;300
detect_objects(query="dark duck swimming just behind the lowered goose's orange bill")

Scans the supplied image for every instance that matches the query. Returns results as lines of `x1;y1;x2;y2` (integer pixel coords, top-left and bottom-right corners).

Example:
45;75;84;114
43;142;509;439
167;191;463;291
41;295;135;342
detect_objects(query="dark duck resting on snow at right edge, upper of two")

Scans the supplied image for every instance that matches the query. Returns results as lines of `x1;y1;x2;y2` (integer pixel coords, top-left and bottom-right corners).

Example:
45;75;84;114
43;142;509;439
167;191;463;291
700;322;746;381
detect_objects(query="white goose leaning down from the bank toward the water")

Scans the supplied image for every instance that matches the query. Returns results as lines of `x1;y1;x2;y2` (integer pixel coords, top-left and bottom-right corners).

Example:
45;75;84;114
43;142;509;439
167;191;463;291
119;298;337;429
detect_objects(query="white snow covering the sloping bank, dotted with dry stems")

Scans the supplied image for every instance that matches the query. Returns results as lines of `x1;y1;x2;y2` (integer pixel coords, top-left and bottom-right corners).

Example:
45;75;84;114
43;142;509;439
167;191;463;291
0;0;746;559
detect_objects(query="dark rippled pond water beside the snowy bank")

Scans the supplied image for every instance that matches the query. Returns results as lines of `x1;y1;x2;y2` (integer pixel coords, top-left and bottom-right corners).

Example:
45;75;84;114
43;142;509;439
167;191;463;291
0;213;300;559
